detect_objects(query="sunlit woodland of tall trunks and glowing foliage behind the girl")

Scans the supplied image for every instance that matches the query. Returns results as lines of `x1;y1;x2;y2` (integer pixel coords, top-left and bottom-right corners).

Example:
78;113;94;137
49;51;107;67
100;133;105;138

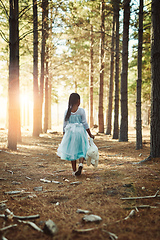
0;0;151;148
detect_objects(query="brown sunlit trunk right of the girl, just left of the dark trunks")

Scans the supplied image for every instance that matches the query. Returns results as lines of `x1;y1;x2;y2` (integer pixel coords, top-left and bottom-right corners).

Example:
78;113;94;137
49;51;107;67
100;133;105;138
98;0;105;133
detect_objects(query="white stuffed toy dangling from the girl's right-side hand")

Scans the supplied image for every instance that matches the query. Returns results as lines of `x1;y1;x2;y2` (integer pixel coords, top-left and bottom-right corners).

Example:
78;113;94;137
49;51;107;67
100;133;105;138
85;138;99;167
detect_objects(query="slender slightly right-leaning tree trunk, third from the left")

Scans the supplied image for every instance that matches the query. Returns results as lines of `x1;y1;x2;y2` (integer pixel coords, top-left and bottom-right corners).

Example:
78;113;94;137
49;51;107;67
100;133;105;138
40;0;48;132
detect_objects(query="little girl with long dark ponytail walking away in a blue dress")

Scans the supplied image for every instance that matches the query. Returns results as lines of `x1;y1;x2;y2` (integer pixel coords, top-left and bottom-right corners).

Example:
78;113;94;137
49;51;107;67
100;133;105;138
57;93;94;176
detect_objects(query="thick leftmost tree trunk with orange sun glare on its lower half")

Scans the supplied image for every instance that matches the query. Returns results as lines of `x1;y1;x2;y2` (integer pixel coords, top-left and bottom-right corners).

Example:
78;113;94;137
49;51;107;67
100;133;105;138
8;0;20;150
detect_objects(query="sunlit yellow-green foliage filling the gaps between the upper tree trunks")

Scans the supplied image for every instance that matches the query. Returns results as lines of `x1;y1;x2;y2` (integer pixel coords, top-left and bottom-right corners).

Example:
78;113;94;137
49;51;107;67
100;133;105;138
0;0;151;126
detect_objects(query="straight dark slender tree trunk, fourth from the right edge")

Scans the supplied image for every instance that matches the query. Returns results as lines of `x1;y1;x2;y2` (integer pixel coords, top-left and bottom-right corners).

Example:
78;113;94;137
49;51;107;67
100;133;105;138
113;0;120;139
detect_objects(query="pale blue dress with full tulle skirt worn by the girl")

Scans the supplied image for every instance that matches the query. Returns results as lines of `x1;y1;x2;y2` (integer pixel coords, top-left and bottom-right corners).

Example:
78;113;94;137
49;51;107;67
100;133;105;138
57;108;89;161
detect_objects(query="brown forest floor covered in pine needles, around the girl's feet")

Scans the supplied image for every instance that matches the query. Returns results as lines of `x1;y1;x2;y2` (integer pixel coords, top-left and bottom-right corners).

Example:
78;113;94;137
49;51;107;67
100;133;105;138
0;128;160;240
